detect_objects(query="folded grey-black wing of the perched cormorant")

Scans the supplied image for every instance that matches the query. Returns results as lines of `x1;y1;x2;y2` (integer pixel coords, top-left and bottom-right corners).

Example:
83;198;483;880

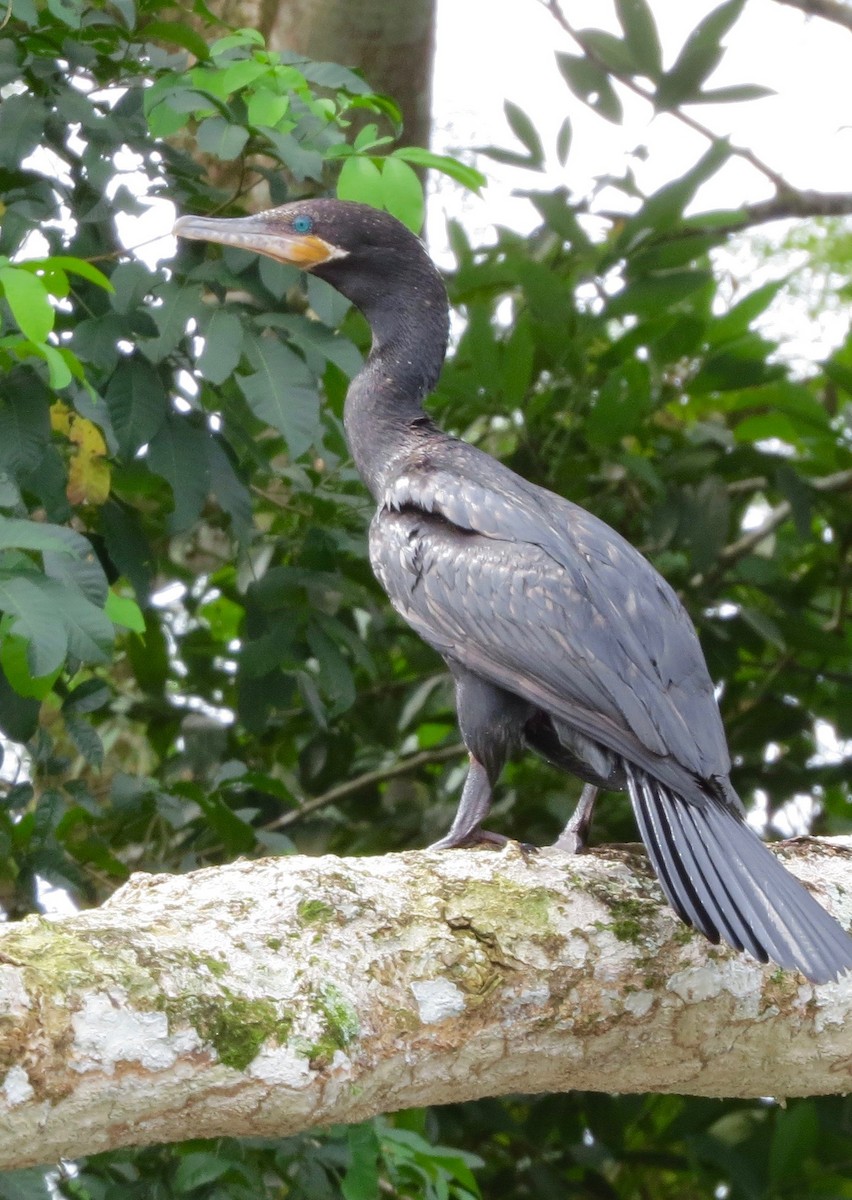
371;448;730;800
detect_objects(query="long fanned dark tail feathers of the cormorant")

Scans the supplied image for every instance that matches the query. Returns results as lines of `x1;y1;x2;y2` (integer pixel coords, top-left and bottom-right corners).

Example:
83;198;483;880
626;764;852;983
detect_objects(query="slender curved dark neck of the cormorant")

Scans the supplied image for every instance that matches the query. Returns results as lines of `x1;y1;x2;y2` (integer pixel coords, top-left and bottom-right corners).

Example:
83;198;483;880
324;250;449;498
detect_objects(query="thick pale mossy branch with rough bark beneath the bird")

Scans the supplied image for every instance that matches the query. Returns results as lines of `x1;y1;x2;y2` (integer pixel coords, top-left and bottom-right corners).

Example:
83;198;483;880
0;838;852;1169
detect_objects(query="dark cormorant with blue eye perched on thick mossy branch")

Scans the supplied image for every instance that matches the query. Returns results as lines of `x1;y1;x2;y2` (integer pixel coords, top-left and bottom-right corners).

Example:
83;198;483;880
174;198;852;983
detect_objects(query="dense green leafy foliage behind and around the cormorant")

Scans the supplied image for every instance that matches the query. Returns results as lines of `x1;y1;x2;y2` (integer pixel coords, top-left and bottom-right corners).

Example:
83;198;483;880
0;0;852;1200
